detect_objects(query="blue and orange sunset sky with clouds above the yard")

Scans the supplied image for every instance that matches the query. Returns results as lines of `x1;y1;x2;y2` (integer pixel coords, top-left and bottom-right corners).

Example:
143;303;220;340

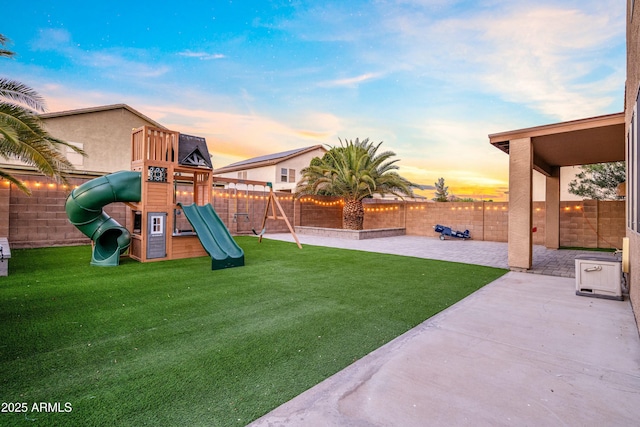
0;0;626;200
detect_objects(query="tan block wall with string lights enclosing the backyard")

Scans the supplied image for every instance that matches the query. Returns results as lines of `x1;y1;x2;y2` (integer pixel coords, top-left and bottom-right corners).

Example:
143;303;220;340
0;175;625;248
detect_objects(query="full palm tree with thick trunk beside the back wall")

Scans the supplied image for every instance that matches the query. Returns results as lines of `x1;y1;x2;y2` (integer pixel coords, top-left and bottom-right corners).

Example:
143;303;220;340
296;138;416;230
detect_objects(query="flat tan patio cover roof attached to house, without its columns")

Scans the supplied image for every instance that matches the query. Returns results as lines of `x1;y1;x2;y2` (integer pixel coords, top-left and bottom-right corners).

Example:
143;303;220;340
489;113;625;175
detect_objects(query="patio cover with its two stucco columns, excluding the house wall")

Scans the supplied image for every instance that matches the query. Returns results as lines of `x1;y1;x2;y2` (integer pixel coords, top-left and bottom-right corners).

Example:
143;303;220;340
489;113;625;270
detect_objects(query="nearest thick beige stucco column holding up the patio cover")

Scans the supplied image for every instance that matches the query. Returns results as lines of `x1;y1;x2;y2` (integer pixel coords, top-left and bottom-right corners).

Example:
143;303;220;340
509;138;533;270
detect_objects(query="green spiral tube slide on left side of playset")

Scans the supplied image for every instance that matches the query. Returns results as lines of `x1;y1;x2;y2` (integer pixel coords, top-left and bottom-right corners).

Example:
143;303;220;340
65;171;142;266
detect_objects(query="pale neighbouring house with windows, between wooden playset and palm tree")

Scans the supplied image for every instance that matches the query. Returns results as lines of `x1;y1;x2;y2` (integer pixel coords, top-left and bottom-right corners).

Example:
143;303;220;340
213;145;327;192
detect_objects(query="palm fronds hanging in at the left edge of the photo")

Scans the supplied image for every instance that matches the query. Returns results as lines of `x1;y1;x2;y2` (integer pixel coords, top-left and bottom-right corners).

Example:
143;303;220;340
0;34;84;194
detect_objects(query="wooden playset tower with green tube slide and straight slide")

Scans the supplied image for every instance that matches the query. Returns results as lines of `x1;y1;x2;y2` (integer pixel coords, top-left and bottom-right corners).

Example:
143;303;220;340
65;126;244;270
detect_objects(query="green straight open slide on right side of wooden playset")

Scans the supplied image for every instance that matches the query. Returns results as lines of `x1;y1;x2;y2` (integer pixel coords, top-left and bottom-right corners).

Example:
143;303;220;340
178;203;244;270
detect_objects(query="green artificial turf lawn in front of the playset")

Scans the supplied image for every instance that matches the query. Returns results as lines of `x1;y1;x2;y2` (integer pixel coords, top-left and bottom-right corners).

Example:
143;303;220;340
0;237;505;426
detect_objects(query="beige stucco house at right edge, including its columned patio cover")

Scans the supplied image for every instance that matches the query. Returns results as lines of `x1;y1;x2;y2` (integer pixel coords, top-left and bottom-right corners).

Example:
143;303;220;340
489;0;640;321
